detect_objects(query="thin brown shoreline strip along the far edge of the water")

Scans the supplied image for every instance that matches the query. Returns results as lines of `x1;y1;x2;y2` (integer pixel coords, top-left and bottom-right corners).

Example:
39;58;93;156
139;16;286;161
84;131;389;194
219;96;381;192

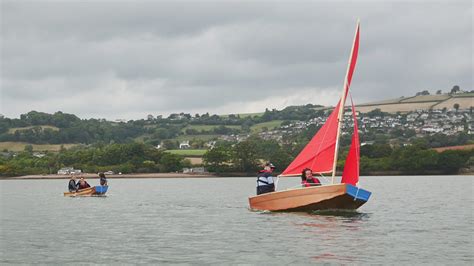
0;172;474;180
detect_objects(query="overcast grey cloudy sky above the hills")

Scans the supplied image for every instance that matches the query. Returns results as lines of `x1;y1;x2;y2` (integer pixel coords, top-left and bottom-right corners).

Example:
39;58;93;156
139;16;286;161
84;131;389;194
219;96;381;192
0;0;474;119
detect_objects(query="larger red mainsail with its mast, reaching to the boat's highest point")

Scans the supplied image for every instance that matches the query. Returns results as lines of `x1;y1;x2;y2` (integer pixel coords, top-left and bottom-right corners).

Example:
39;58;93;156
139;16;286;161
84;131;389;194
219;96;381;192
281;22;359;176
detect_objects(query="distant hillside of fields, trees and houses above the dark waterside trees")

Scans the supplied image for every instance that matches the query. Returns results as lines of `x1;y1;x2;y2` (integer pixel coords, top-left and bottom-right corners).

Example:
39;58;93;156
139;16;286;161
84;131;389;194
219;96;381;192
0;93;474;153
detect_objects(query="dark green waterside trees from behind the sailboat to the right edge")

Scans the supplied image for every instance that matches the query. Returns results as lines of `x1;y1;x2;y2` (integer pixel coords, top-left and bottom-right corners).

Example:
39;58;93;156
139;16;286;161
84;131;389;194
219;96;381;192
203;138;474;175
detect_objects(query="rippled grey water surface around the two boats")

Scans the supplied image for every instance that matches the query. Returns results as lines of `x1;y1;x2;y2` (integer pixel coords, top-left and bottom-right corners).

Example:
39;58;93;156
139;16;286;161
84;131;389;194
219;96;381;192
0;176;474;265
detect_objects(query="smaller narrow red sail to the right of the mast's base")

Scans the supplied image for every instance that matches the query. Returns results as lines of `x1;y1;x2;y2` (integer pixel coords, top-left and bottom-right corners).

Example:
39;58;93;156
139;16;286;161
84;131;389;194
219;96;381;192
341;99;360;186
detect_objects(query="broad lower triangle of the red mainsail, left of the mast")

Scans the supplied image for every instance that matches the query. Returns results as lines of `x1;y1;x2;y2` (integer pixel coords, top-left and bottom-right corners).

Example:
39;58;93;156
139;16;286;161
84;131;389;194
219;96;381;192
281;101;340;176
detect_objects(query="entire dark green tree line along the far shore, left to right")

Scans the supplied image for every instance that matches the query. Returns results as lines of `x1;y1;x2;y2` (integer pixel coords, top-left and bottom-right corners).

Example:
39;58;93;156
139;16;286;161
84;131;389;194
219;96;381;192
0;136;474;176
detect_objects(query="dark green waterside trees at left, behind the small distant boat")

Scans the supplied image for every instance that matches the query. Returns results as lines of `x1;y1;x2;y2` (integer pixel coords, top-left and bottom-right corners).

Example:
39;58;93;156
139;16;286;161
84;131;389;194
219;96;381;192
0;142;190;176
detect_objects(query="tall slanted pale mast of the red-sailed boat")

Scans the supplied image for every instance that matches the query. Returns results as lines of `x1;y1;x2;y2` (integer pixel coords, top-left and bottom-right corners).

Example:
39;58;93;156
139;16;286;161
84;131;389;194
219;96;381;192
331;19;360;184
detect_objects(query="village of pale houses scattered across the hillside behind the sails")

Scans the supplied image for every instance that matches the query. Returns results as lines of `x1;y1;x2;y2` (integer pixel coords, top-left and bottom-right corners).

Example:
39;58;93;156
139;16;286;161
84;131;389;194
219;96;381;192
179;89;474;149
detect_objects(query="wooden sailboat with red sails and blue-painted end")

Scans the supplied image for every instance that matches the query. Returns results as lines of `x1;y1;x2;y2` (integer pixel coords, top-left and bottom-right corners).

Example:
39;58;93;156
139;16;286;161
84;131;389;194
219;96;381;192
249;21;371;212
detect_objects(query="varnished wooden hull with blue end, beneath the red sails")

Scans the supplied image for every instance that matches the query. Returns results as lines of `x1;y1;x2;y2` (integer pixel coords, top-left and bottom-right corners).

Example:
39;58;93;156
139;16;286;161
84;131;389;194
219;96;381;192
249;184;371;212
